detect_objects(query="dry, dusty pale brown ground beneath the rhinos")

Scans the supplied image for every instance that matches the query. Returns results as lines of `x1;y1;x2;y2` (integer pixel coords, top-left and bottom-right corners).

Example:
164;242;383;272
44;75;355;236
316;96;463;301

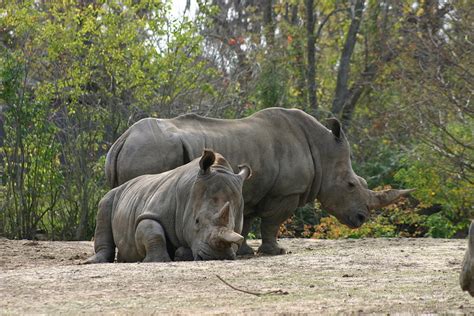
0;239;474;315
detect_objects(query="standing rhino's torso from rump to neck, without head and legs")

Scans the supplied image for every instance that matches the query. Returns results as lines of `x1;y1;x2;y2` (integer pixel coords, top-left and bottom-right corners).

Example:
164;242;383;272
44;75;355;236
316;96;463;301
111;108;327;212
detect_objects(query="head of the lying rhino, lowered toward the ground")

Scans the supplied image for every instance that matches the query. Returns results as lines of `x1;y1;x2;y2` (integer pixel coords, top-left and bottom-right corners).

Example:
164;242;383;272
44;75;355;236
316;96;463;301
186;150;251;260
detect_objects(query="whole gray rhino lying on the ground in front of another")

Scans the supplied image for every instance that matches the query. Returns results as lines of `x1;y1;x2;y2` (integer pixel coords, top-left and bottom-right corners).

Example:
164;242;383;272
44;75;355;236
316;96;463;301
85;150;251;263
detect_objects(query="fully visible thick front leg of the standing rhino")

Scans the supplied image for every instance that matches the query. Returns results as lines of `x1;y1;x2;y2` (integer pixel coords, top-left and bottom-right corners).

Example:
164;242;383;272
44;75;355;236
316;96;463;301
258;194;299;255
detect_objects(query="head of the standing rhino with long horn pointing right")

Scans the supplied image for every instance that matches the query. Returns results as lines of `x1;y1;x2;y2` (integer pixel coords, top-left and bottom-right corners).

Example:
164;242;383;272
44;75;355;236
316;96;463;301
318;119;413;228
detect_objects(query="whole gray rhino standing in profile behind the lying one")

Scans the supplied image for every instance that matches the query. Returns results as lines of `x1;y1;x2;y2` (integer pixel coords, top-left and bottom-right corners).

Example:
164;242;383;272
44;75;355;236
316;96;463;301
105;108;410;254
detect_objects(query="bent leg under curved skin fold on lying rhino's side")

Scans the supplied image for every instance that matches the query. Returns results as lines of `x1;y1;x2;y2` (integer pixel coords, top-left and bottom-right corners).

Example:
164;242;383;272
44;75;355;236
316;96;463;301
135;219;171;262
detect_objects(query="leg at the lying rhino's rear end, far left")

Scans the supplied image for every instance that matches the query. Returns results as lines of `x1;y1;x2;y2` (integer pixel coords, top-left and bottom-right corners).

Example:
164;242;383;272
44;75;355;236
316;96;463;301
84;194;115;264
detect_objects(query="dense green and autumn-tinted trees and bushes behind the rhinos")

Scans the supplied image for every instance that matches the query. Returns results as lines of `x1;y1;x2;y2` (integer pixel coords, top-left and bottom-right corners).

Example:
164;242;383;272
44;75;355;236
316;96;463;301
0;0;474;239
